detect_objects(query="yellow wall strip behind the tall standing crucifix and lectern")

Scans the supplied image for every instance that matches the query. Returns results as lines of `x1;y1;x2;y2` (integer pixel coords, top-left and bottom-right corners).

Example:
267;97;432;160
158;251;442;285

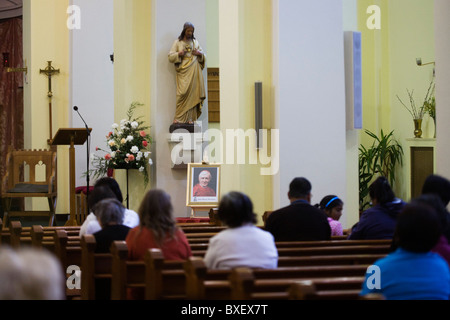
23;0;70;213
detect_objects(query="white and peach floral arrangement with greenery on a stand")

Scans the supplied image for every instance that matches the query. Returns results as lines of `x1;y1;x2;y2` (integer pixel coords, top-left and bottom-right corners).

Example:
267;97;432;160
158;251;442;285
89;102;153;208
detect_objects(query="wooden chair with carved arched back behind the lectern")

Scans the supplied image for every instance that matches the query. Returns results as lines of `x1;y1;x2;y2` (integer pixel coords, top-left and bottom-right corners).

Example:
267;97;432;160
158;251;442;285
2;150;57;228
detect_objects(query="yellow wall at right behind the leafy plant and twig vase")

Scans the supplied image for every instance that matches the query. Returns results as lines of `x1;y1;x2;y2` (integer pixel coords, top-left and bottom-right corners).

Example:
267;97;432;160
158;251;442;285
358;0;434;200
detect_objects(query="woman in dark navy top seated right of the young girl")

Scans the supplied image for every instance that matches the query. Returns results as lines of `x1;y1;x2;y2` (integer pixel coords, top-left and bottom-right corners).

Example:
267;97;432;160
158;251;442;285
348;177;406;240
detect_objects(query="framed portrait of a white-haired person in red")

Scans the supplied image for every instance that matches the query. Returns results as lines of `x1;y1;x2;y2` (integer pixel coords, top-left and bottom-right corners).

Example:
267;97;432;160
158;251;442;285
186;163;220;207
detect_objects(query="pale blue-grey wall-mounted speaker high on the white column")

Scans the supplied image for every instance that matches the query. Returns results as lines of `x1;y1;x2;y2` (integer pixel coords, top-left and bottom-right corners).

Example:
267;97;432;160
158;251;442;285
344;31;363;129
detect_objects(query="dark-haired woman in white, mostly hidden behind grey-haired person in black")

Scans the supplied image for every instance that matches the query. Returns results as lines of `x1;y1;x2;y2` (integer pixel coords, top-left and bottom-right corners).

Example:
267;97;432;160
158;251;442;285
80;177;139;236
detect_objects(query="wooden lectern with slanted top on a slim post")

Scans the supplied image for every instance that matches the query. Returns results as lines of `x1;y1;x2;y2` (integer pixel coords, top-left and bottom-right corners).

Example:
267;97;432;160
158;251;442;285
52;128;92;226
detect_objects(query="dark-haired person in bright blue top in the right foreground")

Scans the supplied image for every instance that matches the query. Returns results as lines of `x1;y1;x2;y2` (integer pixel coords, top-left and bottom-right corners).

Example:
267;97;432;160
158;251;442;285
361;201;450;300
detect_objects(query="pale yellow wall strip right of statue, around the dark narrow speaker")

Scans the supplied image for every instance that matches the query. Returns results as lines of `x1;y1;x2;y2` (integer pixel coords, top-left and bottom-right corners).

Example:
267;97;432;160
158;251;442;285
219;0;273;223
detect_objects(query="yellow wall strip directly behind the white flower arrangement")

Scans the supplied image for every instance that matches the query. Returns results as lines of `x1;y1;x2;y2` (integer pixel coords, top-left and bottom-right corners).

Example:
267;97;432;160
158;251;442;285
114;0;151;211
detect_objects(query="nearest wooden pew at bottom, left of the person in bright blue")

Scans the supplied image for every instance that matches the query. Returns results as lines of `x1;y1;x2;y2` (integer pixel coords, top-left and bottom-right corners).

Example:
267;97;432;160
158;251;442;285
288;278;385;300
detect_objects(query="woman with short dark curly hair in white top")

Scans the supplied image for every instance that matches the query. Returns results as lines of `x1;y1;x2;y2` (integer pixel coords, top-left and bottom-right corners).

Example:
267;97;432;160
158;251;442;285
205;191;278;269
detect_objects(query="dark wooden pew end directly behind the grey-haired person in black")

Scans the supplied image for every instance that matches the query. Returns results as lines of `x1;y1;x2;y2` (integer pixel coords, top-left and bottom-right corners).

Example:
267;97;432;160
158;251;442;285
81;234;112;300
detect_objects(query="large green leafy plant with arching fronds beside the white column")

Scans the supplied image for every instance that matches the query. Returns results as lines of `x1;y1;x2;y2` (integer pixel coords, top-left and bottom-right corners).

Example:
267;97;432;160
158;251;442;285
358;130;403;211
